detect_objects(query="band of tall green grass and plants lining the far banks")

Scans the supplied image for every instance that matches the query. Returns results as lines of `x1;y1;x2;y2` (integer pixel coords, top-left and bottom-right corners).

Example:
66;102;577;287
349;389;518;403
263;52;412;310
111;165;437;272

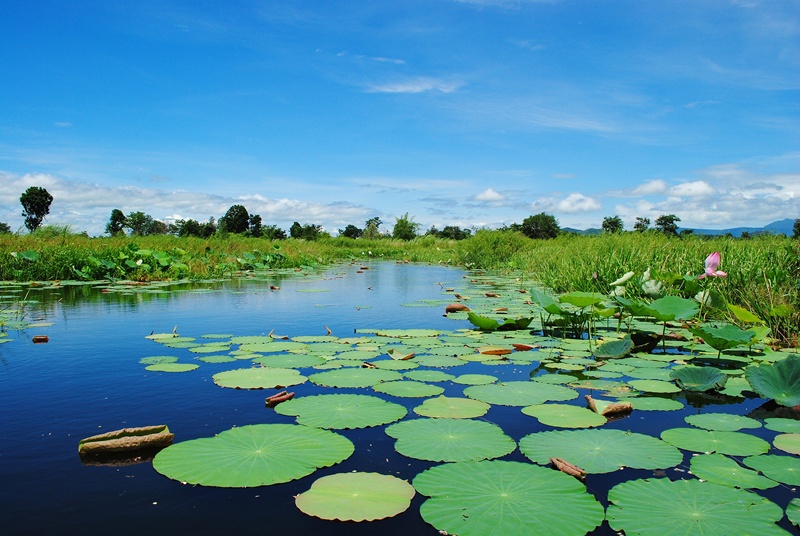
0;226;800;347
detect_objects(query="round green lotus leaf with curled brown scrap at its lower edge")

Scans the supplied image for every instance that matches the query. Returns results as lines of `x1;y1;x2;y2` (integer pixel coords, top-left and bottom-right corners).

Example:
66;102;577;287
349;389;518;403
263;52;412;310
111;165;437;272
519;429;683;473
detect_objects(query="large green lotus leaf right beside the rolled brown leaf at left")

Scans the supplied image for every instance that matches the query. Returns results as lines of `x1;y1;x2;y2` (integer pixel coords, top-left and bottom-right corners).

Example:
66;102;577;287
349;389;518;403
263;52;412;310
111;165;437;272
153;424;354;488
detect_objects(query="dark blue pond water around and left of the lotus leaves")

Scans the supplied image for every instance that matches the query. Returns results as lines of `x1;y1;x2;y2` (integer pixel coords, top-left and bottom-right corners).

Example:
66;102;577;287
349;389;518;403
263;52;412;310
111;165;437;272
0;263;796;535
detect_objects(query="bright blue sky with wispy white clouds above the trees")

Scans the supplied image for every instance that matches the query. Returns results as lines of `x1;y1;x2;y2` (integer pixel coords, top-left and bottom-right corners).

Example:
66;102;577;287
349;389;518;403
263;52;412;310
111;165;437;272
0;0;800;234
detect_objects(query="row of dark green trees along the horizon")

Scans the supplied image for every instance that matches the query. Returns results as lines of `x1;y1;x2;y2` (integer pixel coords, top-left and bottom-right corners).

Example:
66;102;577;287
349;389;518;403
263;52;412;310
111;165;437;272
0;186;800;240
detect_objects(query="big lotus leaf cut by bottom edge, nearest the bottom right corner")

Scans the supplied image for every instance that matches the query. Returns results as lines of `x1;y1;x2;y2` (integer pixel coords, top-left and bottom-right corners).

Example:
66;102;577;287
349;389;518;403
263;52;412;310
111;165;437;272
606;478;786;536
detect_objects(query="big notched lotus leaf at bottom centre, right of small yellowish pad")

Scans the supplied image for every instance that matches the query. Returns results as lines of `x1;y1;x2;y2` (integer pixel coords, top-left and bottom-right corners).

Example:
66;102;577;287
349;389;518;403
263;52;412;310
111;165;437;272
412;461;603;536
